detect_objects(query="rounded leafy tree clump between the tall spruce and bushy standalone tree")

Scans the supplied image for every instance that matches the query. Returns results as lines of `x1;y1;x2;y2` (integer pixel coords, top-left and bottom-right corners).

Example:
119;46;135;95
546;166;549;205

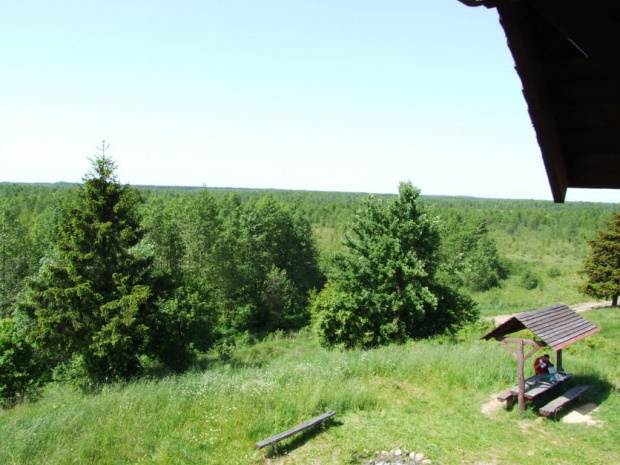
214;196;323;333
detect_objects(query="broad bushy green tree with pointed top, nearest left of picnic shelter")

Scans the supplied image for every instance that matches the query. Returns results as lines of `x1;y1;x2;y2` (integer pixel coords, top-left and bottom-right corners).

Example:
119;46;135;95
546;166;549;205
312;183;477;347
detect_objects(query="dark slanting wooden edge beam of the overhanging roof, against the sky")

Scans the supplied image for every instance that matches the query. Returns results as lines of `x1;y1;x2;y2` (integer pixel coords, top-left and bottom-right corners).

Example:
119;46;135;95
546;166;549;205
497;2;568;203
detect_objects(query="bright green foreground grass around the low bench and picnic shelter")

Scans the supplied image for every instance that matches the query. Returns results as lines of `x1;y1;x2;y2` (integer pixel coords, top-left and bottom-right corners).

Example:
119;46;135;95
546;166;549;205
0;309;620;465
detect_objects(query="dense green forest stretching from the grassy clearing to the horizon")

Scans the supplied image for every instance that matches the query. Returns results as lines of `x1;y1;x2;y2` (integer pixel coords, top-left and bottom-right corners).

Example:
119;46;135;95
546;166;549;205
0;172;617;404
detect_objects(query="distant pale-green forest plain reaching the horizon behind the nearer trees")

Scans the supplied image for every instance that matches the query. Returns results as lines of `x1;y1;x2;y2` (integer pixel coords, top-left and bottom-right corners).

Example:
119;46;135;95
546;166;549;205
0;183;617;315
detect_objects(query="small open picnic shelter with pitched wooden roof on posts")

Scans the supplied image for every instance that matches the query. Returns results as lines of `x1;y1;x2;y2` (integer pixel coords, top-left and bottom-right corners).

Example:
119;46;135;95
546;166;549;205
482;303;600;411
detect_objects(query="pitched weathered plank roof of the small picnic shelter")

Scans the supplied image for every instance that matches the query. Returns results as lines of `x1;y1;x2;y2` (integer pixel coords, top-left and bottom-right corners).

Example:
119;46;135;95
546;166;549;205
483;304;600;350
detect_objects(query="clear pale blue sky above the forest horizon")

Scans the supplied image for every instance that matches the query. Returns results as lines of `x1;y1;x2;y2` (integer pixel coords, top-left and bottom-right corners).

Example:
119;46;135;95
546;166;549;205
0;0;620;202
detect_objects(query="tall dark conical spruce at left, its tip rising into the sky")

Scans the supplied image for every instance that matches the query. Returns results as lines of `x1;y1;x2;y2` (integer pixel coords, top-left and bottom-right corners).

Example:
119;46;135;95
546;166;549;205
23;152;157;382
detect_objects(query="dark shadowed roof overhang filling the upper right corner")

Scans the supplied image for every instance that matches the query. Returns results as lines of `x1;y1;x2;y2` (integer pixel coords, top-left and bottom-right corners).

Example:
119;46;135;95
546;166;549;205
458;0;620;203
